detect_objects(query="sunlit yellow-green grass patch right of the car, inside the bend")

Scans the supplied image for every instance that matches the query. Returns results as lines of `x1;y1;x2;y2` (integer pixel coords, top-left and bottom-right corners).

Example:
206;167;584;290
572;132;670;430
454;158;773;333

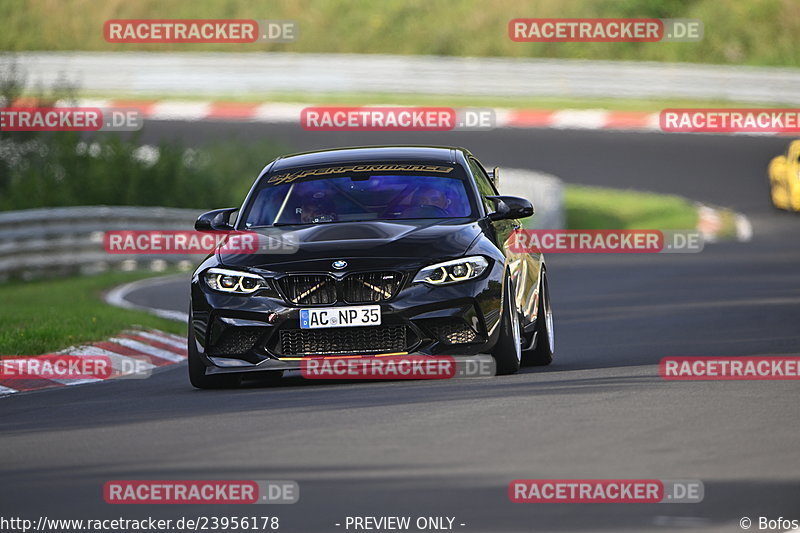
564;185;697;230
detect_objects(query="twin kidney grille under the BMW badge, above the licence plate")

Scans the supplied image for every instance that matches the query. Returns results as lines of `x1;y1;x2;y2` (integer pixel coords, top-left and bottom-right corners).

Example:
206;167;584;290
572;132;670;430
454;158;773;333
279;272;403;305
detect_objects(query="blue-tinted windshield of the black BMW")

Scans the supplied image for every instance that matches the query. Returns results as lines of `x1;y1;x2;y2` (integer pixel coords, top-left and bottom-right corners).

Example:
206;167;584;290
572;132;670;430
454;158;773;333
245;167;473;228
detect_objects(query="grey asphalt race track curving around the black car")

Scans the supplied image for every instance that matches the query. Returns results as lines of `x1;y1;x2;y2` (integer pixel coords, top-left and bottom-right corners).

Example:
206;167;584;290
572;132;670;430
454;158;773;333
0;122;800;532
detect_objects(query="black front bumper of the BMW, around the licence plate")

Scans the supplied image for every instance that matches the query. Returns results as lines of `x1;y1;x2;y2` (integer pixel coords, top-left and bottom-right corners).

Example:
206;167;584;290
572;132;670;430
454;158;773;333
189;263;502;374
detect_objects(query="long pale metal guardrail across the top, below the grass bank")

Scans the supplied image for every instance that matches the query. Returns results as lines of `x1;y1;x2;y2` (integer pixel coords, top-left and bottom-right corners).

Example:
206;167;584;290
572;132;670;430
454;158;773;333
6;52;800;105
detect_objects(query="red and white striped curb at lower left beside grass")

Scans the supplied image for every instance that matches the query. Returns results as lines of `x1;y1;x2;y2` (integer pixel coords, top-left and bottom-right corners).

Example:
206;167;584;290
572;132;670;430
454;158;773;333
0;329;188;396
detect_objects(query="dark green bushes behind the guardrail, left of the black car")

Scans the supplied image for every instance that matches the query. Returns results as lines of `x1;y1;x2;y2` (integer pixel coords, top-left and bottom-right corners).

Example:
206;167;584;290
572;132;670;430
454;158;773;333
0;131;288;211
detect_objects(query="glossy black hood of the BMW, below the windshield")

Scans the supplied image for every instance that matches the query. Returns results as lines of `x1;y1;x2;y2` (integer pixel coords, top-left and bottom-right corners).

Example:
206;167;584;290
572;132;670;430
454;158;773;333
218;219;481;272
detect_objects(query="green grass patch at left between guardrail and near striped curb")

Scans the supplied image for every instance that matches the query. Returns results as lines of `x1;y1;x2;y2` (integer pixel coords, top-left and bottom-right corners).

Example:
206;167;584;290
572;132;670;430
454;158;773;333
0;272;186;356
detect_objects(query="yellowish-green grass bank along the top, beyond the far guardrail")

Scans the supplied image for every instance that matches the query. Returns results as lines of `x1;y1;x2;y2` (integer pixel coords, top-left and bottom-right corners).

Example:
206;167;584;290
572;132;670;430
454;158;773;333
0;0;800;66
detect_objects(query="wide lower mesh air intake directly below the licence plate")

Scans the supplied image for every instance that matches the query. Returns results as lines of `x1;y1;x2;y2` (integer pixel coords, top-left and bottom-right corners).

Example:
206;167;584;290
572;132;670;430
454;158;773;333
281;325;407;355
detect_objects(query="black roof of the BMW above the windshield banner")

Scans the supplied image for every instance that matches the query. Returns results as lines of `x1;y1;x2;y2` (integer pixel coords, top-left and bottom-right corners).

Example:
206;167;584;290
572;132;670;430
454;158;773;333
270;146;470;172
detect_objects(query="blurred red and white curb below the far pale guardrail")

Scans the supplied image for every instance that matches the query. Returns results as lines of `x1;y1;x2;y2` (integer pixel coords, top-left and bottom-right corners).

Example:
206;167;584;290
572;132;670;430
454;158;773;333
50;99;782;136
